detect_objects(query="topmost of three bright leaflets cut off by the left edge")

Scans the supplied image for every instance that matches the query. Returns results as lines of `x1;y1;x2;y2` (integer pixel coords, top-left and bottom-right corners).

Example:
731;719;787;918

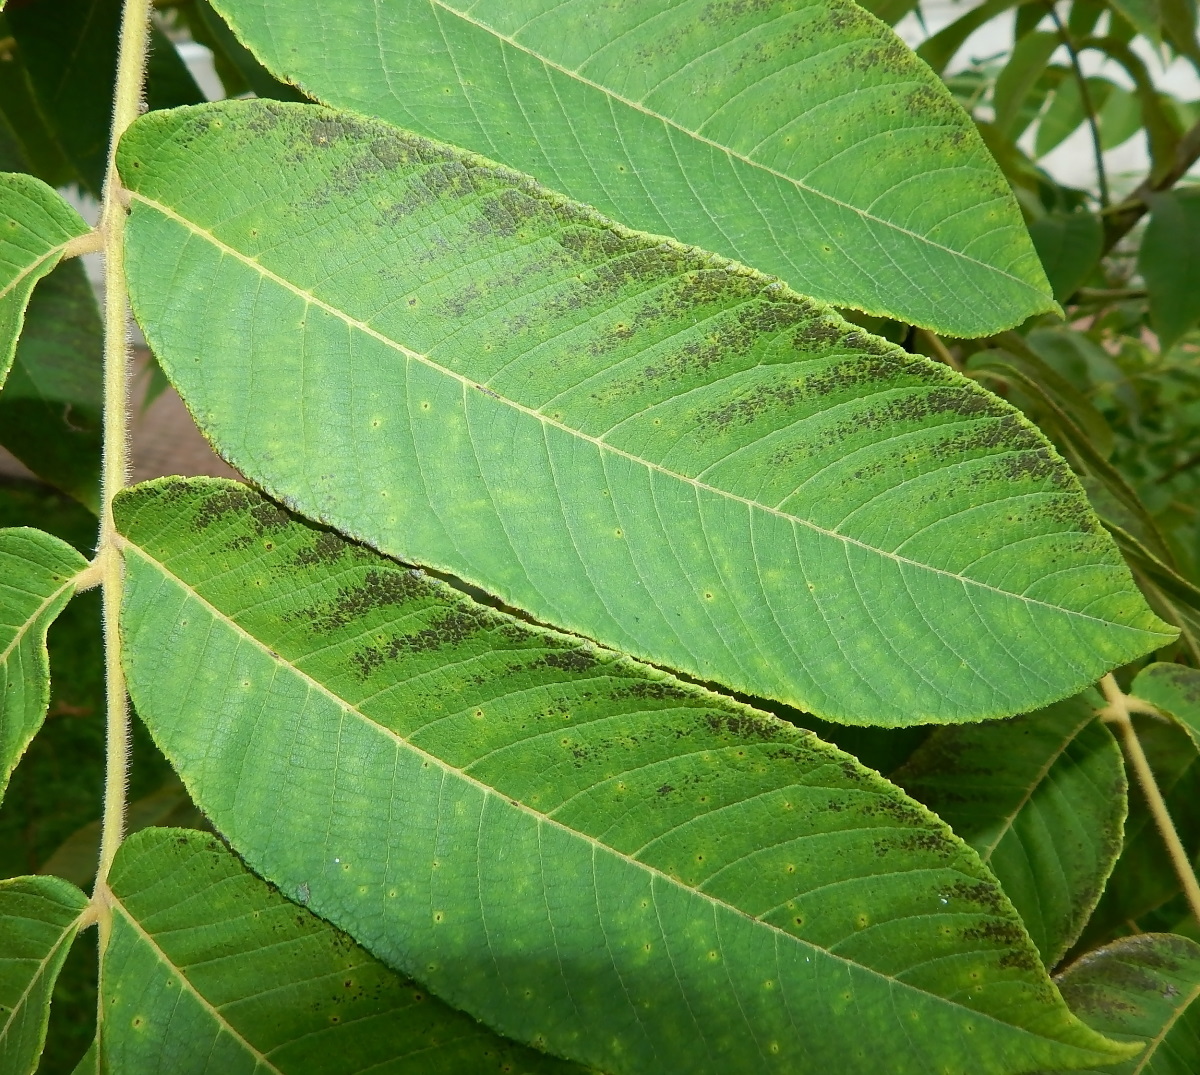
0;172;88;388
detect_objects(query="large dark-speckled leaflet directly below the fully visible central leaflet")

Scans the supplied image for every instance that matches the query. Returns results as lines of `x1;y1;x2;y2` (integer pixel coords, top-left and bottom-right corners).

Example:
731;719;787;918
115;479;1137;1075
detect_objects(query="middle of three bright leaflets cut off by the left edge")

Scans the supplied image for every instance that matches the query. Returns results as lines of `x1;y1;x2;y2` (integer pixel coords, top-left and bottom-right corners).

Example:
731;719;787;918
0;527;88;799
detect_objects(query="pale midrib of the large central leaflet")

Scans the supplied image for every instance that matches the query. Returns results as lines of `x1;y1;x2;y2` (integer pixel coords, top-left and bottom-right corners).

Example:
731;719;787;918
130;191;1152;637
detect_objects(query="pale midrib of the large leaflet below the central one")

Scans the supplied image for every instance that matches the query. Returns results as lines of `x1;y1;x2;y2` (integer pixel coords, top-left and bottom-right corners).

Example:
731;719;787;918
119;535;1097;1056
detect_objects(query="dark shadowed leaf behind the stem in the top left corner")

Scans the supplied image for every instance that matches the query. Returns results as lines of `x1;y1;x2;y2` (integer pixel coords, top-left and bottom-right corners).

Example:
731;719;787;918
6;0;204;197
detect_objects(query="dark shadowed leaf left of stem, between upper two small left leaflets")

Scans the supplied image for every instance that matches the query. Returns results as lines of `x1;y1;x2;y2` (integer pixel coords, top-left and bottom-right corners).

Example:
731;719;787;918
0;260;103;512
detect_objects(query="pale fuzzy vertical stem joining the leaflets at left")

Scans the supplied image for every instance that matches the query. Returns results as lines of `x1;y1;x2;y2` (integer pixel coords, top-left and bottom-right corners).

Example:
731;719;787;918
92;0;150;897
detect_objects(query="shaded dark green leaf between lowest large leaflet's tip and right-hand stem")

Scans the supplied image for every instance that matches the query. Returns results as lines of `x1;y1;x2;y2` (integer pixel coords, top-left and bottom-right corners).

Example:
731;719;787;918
892;691;1127;967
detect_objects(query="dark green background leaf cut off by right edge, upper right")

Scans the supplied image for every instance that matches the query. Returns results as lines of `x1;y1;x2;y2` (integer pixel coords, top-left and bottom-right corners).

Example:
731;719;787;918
1138;188;1200;352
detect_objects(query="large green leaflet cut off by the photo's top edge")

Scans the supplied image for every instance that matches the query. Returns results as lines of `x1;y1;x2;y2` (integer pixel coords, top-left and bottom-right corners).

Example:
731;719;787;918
214;0;1055;336
